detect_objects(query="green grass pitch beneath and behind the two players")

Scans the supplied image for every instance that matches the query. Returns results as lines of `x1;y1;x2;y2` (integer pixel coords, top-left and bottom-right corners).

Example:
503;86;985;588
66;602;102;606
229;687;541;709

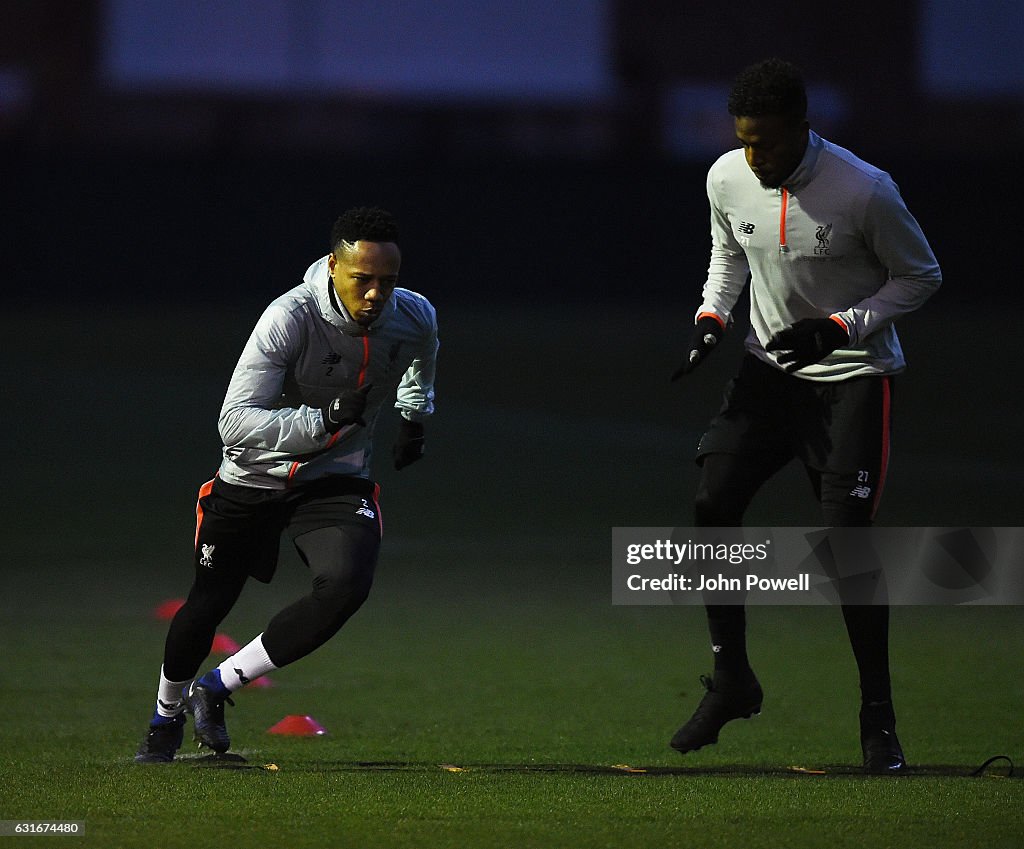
0;301;1024;848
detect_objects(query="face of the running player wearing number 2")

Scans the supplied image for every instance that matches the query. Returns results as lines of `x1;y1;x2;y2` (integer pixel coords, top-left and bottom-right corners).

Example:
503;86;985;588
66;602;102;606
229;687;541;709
327;241;401;326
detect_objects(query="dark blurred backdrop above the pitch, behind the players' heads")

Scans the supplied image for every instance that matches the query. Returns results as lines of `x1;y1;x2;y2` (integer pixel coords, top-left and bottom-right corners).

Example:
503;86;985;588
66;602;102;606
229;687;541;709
0;0;1024;311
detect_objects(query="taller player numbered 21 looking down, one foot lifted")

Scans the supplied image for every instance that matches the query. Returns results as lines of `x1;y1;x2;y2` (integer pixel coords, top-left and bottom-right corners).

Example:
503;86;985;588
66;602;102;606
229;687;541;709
671;59;941;774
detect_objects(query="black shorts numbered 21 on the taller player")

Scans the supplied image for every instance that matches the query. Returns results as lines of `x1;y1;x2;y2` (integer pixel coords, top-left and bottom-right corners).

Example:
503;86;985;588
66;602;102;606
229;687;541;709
697;353;893;503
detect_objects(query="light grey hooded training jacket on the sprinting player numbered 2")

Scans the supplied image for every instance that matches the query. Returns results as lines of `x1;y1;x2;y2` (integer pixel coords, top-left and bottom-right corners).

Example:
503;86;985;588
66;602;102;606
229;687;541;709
218;257;437;490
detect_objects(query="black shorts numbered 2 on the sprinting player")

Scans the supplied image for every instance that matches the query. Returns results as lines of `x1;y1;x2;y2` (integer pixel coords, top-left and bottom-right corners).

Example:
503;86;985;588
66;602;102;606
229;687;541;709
196;475;383;584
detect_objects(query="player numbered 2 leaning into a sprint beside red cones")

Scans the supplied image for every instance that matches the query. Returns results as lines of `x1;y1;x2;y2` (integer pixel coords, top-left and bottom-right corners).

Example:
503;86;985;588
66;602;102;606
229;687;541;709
135;208;437;763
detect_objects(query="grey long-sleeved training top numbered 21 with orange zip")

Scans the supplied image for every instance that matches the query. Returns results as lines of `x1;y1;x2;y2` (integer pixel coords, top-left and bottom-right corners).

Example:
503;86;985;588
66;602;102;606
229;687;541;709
697;132;942;380
